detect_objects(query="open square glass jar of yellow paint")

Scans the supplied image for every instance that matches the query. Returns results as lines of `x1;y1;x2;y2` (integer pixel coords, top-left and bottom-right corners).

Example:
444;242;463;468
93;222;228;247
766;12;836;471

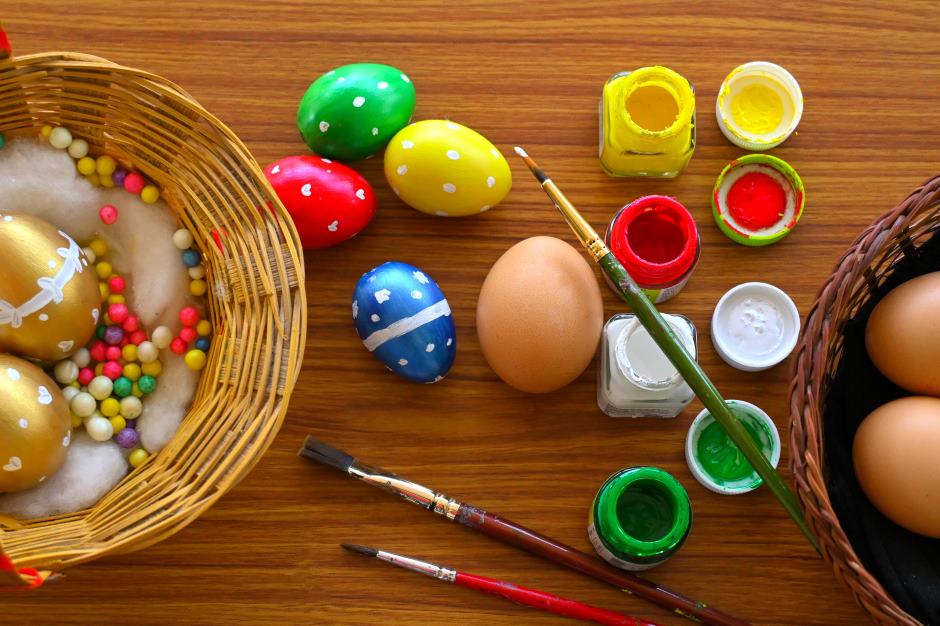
600;66;695;178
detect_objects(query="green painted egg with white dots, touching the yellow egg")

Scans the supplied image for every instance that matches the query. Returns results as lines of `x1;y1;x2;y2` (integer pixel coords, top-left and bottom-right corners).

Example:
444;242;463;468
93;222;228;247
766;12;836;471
297;63;415;161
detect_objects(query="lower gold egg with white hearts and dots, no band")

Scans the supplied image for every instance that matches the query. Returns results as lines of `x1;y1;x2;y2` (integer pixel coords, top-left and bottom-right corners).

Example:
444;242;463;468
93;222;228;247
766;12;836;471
0;354;72;493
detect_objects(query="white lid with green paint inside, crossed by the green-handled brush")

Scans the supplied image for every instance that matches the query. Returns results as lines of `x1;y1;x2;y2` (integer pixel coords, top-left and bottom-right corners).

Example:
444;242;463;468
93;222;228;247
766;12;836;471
685;400;780;495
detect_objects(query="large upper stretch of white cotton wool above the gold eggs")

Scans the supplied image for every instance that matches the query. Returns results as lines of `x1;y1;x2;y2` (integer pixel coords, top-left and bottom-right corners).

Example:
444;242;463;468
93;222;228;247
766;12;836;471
0;139;193;329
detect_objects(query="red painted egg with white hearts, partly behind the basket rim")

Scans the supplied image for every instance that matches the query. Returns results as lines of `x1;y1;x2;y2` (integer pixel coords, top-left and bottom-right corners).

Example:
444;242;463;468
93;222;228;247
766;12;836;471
264;154;375;248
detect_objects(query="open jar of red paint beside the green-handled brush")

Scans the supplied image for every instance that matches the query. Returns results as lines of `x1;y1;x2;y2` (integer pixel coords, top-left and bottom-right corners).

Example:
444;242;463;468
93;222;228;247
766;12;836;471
606;196;701;303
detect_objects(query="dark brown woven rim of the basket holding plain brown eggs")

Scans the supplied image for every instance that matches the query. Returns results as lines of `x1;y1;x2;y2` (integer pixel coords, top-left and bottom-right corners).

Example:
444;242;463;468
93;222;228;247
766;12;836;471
790;176;940;626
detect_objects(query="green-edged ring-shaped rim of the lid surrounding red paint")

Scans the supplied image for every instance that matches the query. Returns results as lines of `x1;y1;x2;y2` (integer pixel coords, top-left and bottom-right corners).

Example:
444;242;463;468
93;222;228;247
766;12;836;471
712;154;806;247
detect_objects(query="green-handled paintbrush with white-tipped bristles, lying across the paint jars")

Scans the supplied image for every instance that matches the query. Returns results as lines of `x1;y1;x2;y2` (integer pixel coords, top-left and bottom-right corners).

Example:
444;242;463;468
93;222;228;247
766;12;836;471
515;146;819;550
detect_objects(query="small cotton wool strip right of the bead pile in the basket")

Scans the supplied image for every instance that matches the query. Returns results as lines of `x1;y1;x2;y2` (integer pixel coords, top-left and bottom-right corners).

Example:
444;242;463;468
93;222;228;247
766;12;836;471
137;355;199;454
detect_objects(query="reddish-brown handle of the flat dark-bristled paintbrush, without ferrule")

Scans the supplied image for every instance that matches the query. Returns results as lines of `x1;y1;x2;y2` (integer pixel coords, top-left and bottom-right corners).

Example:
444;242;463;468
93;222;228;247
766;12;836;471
456;504;749;626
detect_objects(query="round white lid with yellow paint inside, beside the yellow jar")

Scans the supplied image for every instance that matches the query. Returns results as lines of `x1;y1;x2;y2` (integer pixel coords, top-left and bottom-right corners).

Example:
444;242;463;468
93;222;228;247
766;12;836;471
715;61;803;151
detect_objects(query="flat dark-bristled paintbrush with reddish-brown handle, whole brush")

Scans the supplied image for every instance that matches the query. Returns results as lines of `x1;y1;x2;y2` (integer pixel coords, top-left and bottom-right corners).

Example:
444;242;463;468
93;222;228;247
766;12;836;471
300;436;747;626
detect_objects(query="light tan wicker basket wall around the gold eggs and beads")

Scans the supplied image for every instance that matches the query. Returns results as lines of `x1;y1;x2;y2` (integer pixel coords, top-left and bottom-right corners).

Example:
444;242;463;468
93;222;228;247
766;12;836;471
0;23;306;585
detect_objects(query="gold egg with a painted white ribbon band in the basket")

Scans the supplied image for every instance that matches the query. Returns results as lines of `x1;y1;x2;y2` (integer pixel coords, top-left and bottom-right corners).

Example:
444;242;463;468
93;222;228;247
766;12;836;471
0;213;101;361
